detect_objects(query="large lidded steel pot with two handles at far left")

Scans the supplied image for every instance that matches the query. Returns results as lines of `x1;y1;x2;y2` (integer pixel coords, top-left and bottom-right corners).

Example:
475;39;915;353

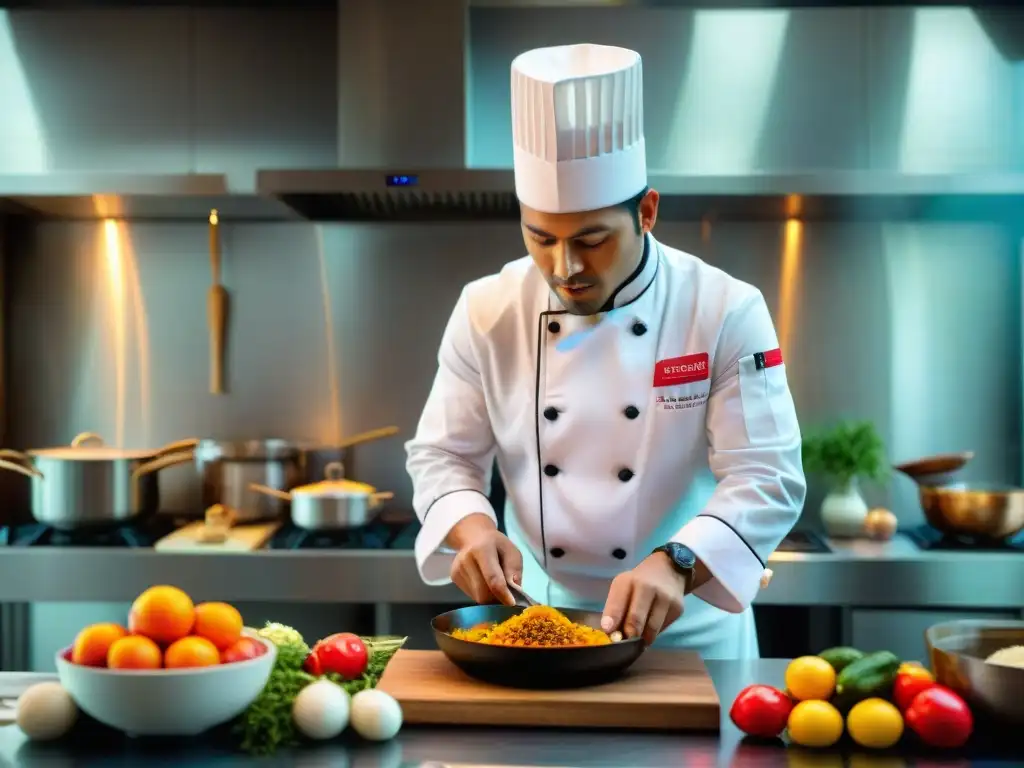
0;432;199;529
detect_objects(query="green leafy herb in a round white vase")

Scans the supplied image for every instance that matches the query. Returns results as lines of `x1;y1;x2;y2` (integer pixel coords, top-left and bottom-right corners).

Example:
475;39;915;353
803;421;888;538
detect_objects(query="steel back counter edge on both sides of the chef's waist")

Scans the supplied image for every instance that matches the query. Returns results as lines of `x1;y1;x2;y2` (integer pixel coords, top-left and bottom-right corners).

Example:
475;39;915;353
0;536;1024;610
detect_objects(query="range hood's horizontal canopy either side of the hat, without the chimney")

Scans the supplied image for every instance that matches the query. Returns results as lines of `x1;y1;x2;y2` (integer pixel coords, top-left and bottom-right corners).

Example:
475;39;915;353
257;169;1024;221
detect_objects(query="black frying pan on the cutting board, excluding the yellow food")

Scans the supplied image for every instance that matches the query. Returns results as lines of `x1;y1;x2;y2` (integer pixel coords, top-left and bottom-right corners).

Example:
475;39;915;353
430;605;644;689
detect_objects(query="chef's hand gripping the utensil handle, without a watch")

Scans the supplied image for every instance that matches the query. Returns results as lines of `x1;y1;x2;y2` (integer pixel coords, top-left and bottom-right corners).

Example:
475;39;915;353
447;514;522;605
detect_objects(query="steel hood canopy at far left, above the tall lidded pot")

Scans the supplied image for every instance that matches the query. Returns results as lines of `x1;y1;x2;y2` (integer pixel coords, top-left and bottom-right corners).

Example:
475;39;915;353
0;173;299;221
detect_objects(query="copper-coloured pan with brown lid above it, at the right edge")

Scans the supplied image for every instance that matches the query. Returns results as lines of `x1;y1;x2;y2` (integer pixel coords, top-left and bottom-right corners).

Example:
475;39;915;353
895;452;1024;542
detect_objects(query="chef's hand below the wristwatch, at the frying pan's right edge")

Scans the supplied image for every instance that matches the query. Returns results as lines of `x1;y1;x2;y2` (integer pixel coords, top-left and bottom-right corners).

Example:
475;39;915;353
601;552;686;645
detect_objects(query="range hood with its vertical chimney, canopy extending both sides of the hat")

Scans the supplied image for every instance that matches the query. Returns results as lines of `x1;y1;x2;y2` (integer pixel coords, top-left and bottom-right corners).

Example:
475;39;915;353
256;0;1024;221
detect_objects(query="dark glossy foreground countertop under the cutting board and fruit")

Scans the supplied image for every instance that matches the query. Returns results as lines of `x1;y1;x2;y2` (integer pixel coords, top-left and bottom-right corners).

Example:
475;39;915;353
0;659;1020;768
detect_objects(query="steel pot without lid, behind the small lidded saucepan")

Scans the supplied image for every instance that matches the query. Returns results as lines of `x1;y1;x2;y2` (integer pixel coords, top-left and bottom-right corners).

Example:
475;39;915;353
196;439;306;522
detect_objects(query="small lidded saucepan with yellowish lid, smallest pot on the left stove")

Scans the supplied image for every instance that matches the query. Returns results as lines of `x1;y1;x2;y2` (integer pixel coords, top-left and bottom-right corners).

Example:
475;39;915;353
249;462;394;530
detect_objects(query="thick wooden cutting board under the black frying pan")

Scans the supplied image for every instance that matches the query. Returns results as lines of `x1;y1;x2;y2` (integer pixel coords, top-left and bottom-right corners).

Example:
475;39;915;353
378;650;721;730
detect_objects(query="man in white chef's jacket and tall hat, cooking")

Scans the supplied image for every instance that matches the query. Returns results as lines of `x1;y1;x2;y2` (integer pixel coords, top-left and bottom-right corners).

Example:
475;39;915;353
407;45;806;658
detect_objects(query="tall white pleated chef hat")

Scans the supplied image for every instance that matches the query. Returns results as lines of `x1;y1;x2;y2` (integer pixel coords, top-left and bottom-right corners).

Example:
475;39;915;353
512;44;647;213
